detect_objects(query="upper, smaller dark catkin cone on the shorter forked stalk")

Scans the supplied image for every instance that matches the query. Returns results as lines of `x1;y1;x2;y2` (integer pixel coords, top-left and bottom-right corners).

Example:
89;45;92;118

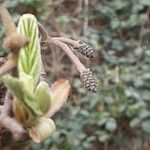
76;41;95;58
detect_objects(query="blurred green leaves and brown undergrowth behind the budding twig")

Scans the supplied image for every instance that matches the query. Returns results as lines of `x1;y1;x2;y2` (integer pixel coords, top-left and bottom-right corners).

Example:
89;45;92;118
0;0;150;150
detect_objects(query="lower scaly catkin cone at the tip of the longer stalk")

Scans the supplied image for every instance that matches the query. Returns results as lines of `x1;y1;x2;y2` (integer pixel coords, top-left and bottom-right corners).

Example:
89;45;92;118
80;69;98;93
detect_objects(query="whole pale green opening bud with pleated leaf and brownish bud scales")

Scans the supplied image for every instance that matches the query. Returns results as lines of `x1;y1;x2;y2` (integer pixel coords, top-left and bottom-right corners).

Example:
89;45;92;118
2;14;70;143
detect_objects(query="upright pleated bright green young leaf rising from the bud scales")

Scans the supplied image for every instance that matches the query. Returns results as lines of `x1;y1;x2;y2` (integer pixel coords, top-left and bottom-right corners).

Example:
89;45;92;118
17;14;41;83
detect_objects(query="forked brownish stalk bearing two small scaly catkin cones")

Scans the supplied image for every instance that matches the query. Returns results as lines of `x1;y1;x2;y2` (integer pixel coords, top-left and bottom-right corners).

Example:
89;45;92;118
39;23;98;93
